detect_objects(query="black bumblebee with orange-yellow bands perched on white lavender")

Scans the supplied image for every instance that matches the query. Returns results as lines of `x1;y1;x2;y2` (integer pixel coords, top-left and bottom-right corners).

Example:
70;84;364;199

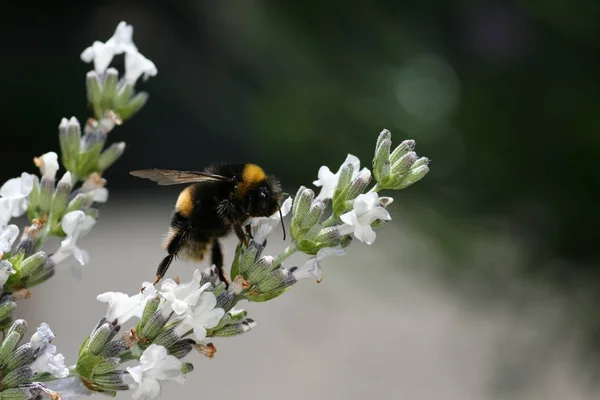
130;164;285;286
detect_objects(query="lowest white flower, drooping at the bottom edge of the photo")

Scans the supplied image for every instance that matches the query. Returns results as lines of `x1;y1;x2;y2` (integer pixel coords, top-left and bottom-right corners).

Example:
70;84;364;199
127;344;185;400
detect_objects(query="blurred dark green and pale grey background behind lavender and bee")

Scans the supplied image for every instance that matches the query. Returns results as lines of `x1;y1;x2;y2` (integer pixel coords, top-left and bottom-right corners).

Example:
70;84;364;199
0;0;600;400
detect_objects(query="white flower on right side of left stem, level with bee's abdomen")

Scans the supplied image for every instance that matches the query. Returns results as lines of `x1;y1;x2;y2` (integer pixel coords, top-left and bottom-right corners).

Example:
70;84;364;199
52;210;96;265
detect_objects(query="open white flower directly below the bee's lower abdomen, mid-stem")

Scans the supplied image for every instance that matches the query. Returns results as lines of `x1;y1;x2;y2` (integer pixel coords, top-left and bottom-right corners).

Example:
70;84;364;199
176;292;225;341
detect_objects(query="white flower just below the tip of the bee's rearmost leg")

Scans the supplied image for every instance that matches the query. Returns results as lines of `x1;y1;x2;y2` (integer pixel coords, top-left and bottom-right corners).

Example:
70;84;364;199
96;282;156;325
